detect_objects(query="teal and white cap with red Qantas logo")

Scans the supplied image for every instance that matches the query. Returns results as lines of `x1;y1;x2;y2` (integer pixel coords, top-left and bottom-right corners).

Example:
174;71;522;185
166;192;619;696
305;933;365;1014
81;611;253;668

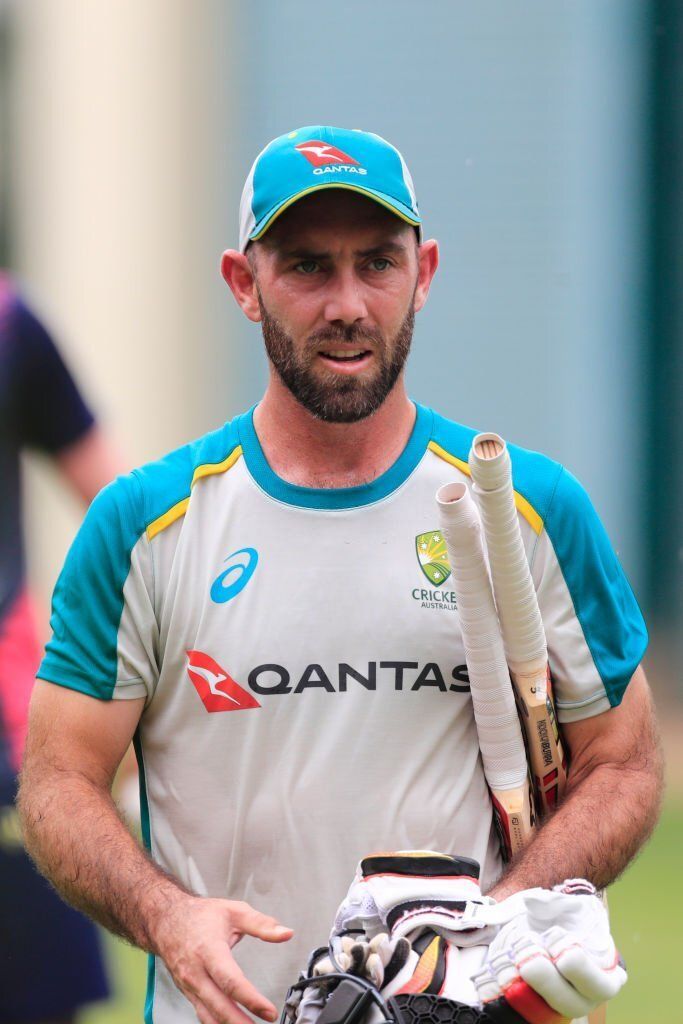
240;125;421;252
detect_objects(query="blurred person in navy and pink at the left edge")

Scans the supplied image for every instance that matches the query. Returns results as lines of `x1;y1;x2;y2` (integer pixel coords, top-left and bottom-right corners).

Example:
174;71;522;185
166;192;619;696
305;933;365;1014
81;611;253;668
0;272;121;1024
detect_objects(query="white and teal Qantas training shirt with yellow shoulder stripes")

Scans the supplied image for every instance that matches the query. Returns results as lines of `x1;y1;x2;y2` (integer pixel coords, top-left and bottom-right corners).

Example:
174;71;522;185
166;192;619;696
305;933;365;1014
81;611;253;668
39;407;646;1024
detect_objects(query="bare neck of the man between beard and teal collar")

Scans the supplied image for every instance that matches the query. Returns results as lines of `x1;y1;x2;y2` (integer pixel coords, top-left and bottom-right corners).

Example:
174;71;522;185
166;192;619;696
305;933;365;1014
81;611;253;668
254;375;416;487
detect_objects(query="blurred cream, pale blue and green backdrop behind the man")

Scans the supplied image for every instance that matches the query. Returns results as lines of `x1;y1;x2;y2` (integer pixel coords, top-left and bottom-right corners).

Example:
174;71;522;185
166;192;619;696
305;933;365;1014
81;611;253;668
0;0;683;1024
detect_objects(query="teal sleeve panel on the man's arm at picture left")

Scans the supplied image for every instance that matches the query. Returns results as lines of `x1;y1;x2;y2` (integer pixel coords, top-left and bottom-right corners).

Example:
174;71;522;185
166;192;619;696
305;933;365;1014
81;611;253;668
38;474;144;700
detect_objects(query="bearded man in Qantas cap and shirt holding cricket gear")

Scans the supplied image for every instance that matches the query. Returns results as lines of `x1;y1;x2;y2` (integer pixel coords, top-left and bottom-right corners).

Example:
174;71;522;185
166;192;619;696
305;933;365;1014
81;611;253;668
22;126;660;1024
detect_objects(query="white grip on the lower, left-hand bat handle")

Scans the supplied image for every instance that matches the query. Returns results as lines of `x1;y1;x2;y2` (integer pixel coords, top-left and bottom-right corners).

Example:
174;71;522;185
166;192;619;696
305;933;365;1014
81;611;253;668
436;483;526;791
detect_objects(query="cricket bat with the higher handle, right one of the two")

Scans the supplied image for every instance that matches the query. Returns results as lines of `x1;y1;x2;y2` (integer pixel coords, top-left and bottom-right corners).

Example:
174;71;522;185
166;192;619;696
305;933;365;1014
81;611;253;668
469;433;566;816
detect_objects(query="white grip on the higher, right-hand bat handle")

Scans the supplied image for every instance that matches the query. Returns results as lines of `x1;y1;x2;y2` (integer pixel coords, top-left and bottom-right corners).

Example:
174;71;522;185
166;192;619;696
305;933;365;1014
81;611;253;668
469;434;548;672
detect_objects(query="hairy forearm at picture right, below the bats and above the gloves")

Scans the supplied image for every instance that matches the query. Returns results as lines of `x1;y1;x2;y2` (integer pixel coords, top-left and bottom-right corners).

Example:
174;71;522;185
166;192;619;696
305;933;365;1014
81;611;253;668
492;745;663;899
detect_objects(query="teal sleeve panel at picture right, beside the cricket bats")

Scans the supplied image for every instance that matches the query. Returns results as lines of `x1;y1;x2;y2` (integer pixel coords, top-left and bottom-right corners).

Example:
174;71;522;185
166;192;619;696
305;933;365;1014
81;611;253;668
545;470;647;707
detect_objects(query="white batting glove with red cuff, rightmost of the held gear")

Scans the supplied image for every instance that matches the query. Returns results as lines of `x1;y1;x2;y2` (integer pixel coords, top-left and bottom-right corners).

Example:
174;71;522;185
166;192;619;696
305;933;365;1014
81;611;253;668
472;879;627;1024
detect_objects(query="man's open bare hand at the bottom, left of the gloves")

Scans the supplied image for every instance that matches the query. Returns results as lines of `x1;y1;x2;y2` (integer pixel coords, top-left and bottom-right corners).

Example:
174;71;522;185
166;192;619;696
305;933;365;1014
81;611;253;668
152;894;293;1024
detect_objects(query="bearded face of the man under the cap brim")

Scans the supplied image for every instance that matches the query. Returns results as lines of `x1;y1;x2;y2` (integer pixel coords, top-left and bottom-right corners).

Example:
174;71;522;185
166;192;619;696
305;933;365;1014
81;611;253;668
250;189;418;423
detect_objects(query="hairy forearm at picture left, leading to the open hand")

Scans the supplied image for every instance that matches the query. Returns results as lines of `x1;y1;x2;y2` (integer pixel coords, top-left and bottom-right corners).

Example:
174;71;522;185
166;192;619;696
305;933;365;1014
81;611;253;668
18;768;188;952
